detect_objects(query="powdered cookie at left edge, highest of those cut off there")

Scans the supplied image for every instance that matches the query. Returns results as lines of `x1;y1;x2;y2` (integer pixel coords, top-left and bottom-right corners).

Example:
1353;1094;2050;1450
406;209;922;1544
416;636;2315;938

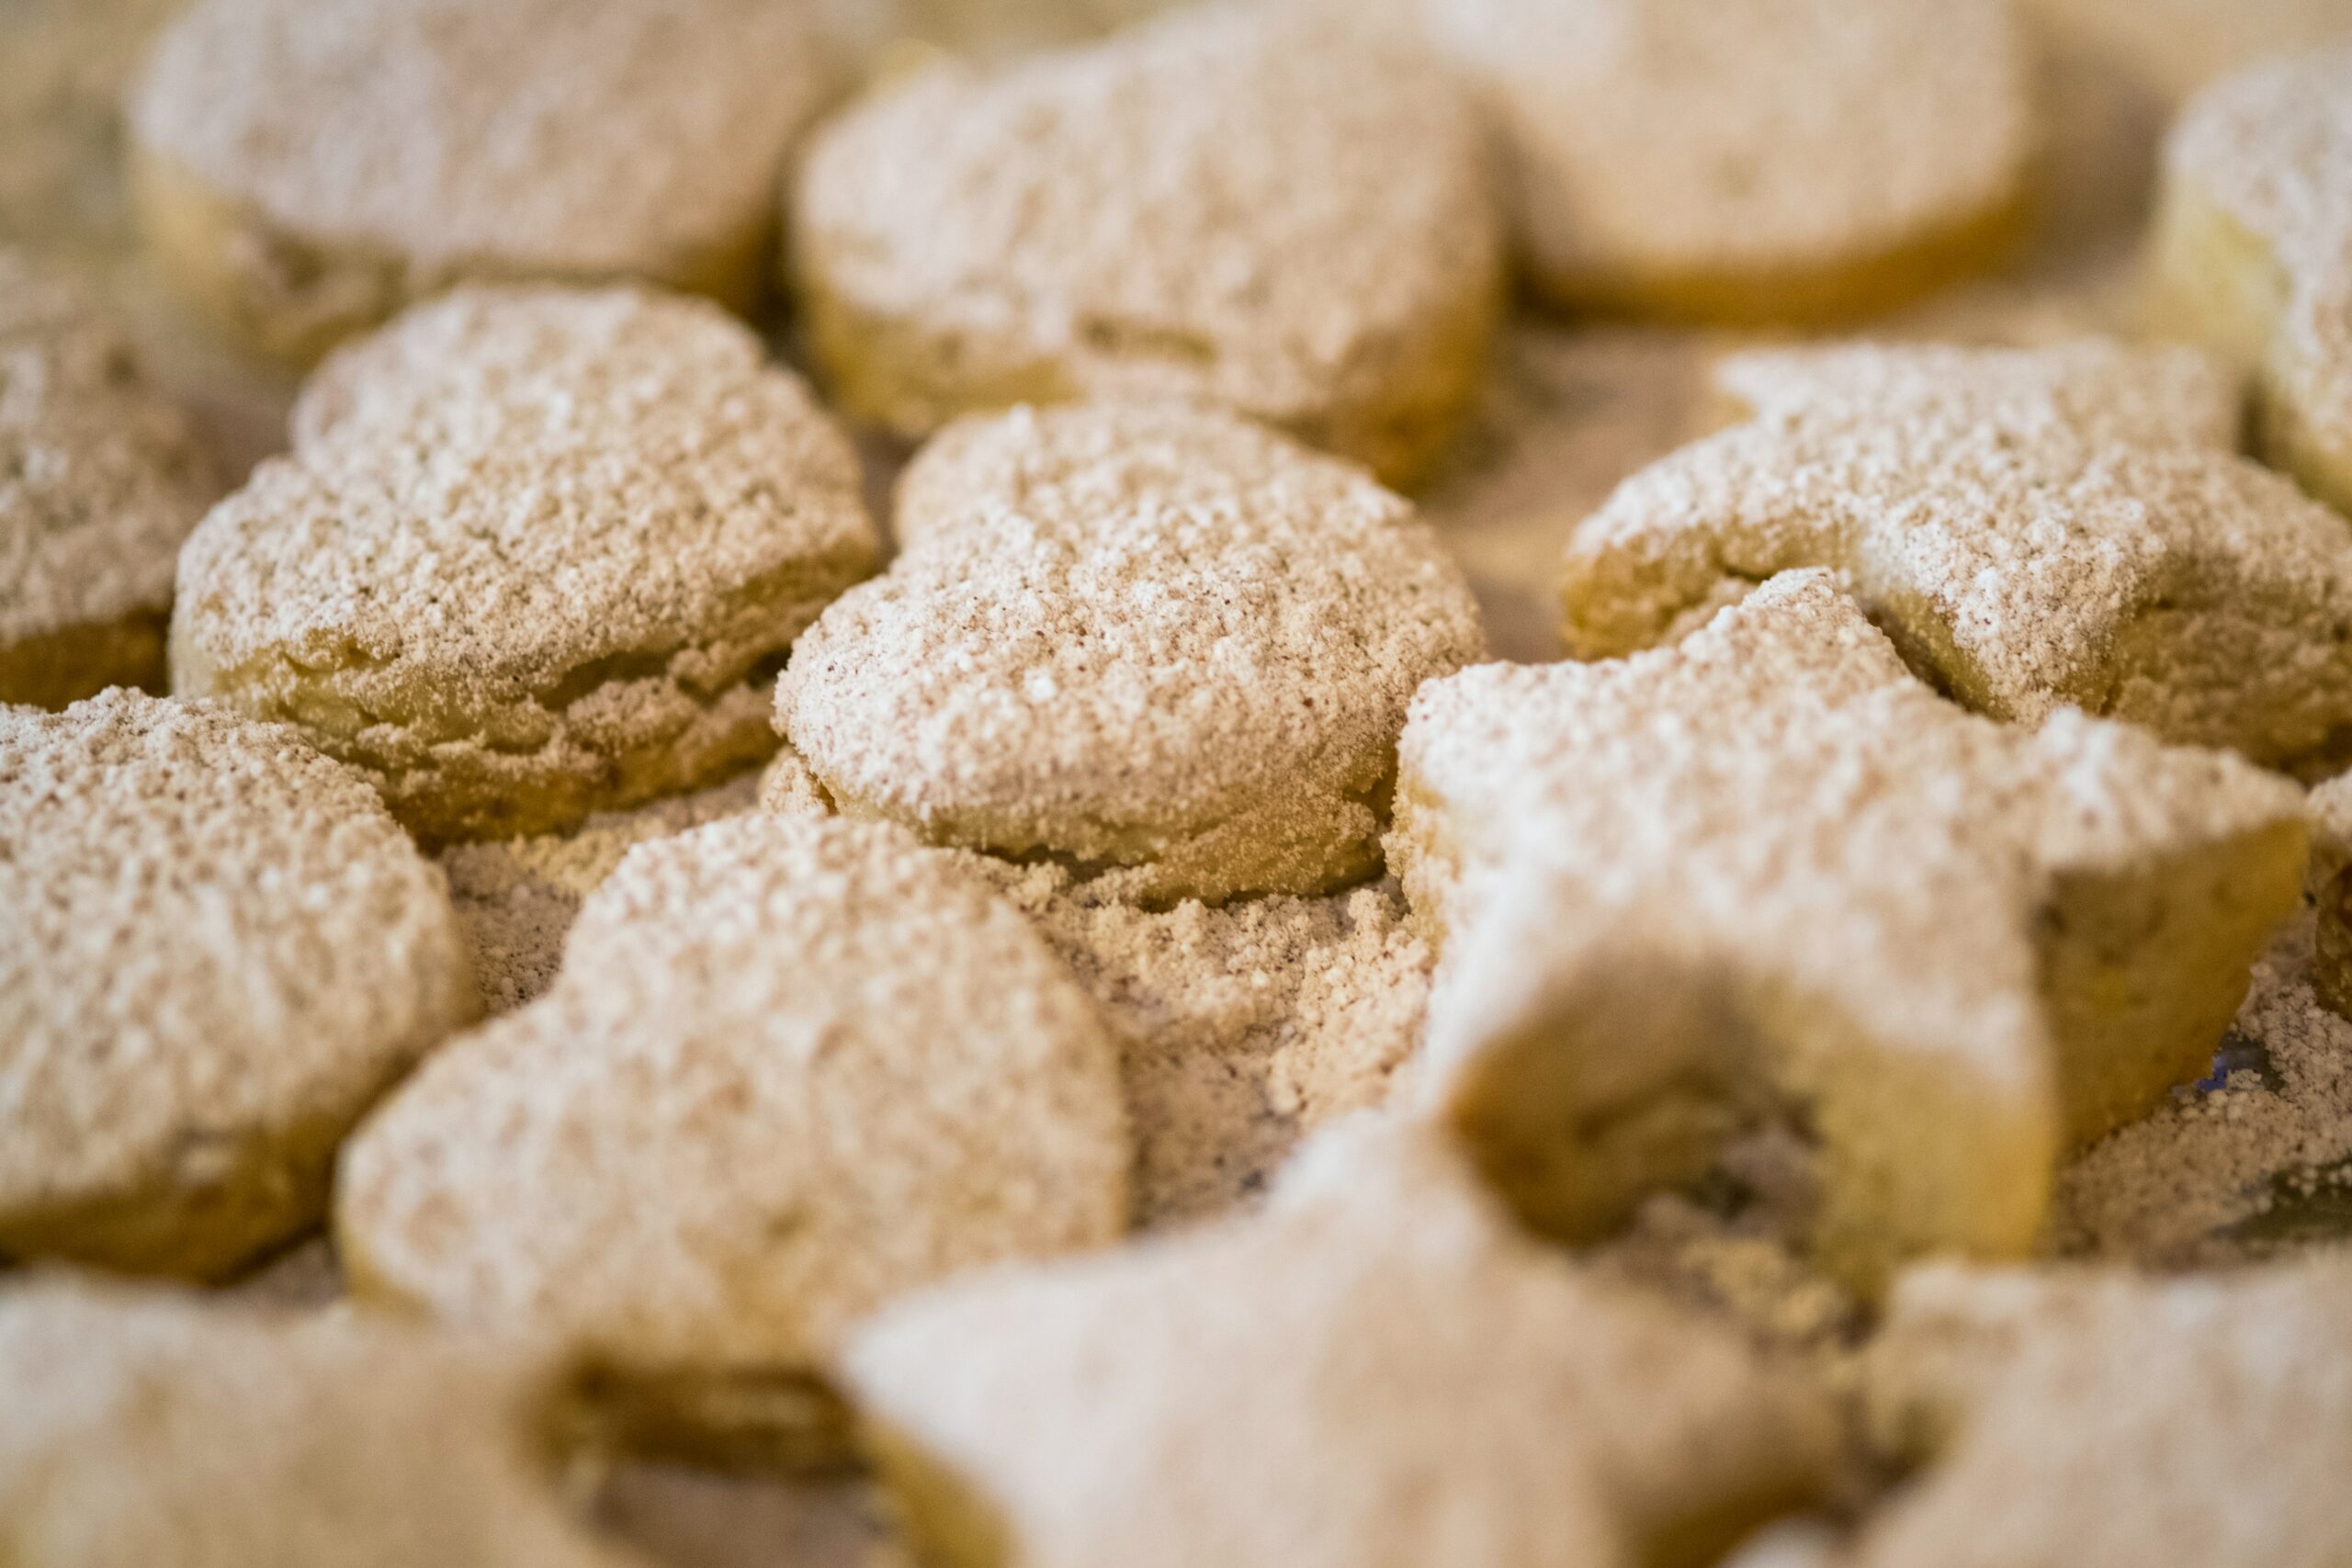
0;247;221;707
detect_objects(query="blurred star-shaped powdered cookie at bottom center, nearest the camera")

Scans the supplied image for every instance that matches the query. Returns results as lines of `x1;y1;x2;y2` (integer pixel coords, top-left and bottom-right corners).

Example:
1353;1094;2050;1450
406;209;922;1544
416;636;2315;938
844;1123;1835;1568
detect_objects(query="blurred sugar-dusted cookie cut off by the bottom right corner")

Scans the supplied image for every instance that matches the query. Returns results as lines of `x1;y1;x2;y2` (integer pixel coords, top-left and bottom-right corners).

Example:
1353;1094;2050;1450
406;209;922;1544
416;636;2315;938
1841;1258;2352;1568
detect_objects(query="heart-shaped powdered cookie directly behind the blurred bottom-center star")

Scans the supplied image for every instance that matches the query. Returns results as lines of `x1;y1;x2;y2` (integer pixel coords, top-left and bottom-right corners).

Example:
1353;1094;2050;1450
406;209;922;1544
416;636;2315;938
336;816;1129;1460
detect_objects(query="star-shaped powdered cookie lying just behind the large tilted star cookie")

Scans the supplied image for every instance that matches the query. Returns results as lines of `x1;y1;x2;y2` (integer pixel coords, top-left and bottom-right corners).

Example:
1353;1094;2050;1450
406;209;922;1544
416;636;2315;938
1562;341;2352;764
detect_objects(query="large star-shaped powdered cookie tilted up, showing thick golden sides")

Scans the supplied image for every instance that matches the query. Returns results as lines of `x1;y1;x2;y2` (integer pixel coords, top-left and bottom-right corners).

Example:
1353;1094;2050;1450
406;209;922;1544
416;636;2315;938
1390;571;2305;1288
